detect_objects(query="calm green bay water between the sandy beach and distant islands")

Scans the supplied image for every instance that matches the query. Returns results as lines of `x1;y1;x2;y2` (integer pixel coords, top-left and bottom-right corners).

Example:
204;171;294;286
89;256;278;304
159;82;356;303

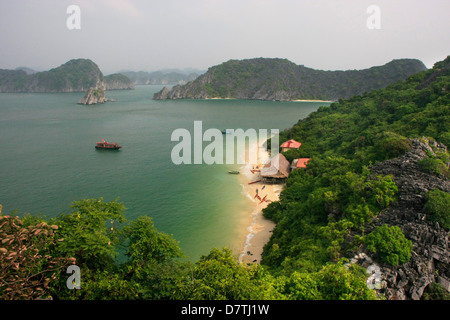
0;86;327;260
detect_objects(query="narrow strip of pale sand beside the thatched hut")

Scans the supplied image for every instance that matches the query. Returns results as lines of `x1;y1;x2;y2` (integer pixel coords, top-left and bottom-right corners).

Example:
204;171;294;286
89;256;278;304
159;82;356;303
234;143;283;264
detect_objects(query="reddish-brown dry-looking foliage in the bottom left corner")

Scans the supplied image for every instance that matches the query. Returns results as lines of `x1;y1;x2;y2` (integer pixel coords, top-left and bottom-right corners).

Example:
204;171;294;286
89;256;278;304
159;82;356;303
0;215;75;300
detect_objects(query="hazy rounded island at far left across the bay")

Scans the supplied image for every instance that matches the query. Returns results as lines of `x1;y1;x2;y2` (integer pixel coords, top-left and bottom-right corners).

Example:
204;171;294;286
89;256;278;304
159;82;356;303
0;59;135;92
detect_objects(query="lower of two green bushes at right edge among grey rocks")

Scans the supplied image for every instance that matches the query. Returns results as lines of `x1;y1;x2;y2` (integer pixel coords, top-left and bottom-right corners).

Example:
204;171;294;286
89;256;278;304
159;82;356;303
425;189;450;229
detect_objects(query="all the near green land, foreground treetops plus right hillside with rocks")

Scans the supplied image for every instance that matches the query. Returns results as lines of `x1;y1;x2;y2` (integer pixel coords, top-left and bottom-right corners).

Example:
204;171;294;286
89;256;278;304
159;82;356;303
0;57;450;300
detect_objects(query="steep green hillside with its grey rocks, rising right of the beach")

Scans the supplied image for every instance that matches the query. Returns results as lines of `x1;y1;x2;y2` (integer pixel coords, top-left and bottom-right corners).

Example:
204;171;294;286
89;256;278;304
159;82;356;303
262;56;450;299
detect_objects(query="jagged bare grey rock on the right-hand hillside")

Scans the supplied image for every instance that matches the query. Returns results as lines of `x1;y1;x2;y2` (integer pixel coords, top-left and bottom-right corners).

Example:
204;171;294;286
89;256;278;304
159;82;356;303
353;139;450;300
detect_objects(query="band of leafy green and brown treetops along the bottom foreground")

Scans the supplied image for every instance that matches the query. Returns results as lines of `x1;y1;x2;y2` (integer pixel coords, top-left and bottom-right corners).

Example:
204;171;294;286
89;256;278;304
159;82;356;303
0;199;376;300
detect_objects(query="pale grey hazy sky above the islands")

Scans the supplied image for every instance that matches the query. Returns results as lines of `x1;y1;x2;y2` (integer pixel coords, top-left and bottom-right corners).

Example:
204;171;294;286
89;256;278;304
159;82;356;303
0;0;450;74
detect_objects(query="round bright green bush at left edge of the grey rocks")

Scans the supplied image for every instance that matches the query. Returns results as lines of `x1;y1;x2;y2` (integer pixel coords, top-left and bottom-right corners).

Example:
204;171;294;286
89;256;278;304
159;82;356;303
365;225;412;266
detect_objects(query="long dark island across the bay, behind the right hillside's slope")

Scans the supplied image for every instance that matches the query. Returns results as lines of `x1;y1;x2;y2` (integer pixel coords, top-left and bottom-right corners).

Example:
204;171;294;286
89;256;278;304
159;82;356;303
153;58;427;101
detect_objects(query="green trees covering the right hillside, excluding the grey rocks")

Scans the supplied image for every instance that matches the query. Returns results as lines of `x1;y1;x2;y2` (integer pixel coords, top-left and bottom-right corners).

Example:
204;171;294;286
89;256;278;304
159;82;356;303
262;57;450;274
